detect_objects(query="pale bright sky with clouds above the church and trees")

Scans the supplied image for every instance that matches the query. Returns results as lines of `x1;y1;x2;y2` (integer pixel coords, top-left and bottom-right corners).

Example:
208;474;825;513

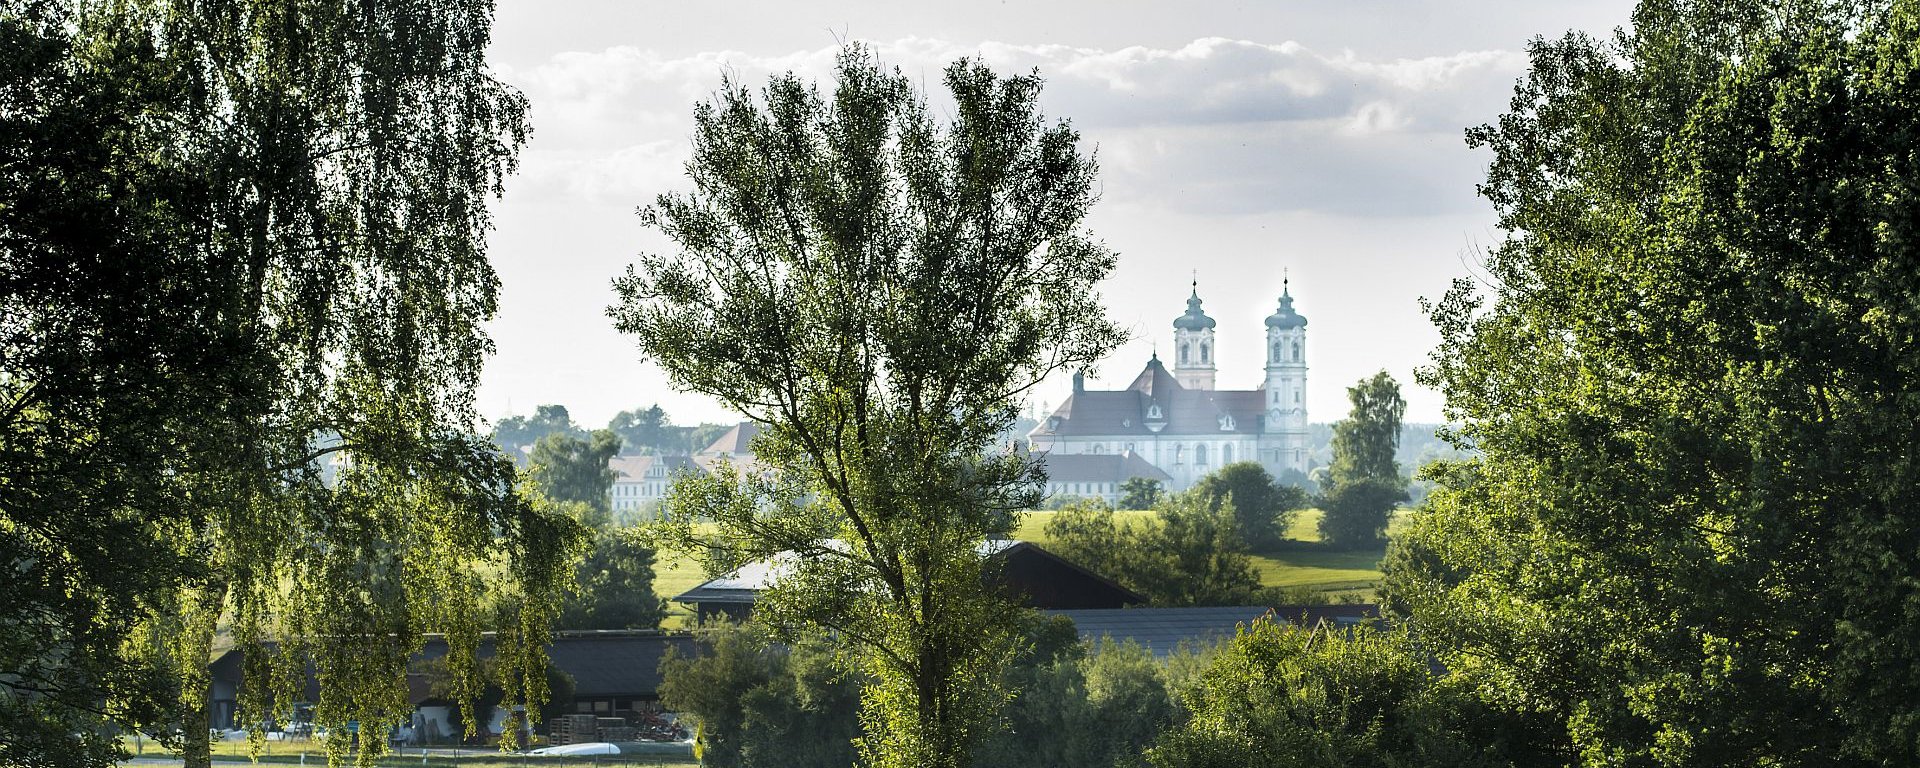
478;0;1630;426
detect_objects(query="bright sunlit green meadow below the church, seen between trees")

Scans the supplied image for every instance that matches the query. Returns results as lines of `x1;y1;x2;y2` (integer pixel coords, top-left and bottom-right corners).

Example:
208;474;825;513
653;509;1405;628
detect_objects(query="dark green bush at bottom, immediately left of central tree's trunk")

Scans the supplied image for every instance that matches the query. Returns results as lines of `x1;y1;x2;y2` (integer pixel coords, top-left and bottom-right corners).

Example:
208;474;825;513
660;624;860;768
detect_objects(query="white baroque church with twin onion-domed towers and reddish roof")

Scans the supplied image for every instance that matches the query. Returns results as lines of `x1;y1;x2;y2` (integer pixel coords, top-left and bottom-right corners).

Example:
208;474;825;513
1027;278;1308;501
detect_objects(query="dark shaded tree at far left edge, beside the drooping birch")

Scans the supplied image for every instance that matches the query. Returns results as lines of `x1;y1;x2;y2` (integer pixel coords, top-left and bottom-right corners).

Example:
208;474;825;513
0;0;224;766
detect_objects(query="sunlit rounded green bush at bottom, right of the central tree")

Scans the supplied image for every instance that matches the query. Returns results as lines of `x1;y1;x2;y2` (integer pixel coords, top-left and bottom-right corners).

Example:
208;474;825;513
1146;618;1542;768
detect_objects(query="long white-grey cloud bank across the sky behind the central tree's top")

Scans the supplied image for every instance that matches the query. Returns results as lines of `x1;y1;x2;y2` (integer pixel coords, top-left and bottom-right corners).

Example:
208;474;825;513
501;36;1526;215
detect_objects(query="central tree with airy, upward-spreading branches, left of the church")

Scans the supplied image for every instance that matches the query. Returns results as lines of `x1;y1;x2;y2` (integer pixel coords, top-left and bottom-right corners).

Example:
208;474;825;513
609;48;1121;768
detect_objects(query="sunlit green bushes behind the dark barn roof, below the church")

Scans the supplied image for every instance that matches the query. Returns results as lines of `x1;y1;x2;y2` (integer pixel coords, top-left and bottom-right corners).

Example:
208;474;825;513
1046;493;1269;607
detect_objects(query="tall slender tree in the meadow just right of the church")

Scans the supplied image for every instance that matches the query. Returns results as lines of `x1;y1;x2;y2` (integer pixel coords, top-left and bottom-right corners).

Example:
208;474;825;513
1319;371;1407;549
